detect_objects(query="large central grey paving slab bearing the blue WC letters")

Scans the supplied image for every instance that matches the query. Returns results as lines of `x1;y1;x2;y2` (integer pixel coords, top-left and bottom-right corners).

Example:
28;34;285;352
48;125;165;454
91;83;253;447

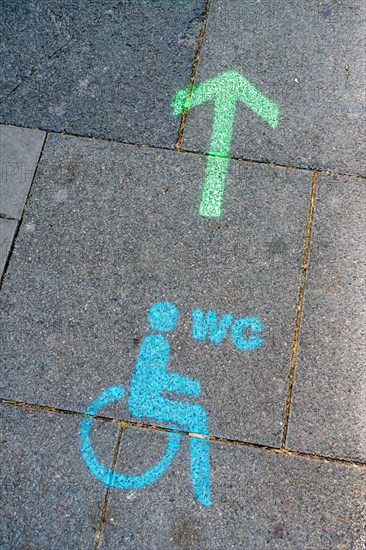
1;135;311;445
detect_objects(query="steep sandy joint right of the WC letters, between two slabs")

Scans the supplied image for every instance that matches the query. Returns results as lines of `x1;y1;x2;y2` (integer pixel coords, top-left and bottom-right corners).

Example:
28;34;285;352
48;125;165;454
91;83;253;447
281;170;318;450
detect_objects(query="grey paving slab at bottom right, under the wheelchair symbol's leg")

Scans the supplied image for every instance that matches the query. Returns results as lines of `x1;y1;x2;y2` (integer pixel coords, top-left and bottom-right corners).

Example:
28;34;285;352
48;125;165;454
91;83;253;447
100;428;366;550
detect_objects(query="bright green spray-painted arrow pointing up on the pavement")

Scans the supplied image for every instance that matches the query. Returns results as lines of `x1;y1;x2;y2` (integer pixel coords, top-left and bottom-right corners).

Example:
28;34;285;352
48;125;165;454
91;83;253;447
172;70;279;218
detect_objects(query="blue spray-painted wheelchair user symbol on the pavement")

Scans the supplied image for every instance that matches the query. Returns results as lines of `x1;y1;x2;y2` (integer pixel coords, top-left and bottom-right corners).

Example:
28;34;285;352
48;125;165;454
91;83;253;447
80;302;211;506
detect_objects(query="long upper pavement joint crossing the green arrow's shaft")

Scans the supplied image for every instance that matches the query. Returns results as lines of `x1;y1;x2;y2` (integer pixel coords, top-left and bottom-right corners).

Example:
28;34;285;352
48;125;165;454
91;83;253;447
0;121;366;180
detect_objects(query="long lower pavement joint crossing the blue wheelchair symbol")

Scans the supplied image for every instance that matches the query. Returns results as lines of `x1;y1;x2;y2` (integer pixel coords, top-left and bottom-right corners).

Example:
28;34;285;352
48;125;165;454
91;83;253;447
0;398;366;468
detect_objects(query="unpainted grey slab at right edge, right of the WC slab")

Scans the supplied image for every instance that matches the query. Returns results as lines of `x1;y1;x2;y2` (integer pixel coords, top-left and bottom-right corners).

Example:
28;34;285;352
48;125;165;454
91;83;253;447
288;175;366;462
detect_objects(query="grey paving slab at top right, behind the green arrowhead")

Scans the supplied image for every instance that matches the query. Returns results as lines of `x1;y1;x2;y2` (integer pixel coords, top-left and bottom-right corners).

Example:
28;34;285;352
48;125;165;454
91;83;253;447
181;0;366;175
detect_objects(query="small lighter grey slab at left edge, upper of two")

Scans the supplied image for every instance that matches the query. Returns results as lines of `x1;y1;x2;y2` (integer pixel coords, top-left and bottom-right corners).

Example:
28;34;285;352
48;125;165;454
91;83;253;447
0;125;46;220
